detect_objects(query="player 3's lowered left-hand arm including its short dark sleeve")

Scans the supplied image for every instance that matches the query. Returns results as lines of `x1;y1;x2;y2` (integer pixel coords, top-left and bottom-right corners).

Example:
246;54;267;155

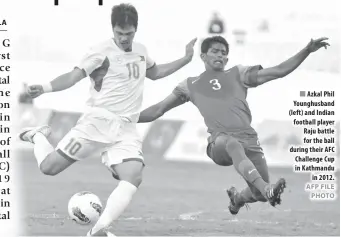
138;80;190;123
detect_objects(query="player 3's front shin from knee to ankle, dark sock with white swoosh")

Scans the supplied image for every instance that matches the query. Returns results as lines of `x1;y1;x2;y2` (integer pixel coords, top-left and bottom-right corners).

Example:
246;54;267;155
226;141;268;195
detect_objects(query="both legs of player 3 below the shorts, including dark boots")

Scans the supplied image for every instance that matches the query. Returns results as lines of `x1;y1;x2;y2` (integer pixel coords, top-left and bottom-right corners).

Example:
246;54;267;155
208;134;285;215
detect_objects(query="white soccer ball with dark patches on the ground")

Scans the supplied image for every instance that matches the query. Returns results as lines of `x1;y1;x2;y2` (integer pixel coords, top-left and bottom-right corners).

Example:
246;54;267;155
68;191;103;225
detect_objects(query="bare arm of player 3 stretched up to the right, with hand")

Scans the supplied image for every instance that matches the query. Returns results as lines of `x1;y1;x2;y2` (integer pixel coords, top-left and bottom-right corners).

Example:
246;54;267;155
253;38;329;85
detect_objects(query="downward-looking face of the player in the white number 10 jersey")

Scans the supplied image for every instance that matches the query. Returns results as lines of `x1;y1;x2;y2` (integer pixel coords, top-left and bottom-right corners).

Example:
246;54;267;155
113;25;136;51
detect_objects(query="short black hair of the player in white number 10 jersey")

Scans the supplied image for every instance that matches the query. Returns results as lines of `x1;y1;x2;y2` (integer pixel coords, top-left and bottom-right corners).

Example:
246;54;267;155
111;3;139;30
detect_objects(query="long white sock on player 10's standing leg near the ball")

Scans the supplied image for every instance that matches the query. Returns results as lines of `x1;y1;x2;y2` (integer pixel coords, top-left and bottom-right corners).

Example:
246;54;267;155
91;181;137;235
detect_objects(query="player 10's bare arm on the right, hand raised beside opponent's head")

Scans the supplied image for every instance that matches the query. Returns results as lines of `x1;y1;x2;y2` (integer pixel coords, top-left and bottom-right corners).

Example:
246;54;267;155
146;38;197;80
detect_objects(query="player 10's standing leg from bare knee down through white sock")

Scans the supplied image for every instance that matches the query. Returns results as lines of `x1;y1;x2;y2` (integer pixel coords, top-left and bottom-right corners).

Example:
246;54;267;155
88;159;144;236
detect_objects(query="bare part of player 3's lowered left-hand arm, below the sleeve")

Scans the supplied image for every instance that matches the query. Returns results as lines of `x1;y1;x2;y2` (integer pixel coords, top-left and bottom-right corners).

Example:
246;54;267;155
138;93;185;123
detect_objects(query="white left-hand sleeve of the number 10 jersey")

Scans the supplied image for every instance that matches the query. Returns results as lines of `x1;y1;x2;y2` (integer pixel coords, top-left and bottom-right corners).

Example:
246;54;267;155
77;50;105;76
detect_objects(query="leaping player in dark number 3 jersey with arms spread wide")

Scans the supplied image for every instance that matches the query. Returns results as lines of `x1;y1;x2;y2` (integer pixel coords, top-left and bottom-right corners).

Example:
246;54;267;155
139;36;329;215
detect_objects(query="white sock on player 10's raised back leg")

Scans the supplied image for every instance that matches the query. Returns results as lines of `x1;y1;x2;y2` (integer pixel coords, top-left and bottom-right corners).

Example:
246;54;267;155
33;132;54;168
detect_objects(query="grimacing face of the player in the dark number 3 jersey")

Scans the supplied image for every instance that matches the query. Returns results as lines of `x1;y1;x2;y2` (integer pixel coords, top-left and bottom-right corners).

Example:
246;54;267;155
201;43;228;71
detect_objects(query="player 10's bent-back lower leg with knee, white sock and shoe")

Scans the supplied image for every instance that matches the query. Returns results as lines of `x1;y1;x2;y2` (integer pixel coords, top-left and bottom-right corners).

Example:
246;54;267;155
19;125;75;175
